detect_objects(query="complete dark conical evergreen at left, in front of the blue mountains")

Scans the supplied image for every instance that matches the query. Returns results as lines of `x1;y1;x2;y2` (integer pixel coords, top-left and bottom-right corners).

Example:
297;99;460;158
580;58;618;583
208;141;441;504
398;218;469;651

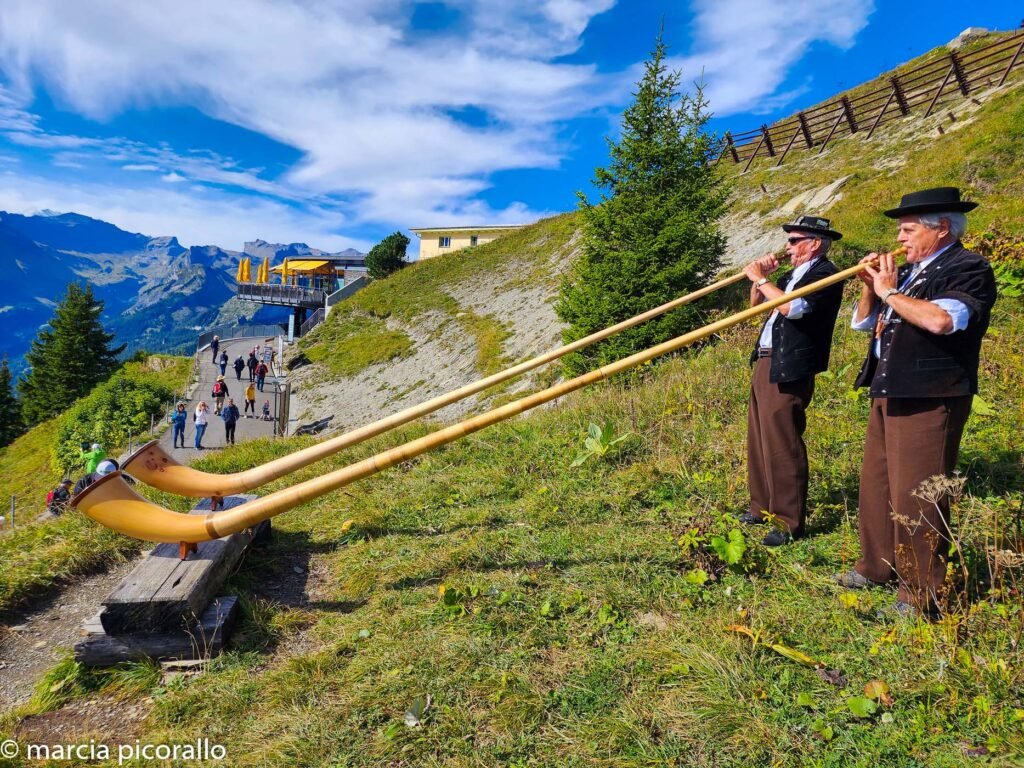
17;283;124;424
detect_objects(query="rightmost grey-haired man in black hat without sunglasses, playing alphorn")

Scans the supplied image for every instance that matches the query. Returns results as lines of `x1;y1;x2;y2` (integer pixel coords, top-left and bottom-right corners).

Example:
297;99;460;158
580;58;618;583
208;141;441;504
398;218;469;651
838;186;995;615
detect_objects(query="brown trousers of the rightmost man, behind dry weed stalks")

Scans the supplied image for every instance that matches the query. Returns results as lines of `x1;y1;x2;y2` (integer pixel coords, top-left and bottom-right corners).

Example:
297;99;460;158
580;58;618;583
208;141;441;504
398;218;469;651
856;395;972;608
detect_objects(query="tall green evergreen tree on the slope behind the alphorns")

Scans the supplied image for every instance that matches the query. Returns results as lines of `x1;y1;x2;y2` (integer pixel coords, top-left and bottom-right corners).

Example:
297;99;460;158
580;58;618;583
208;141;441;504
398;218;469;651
555;35;728;374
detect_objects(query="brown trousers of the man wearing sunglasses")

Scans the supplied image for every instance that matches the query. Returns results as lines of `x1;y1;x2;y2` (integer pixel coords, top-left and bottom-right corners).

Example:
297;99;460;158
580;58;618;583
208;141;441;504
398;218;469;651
746;357;814;536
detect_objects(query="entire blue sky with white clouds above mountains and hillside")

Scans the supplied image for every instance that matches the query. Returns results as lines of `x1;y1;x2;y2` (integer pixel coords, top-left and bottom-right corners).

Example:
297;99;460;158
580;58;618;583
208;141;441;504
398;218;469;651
0;0;1024;250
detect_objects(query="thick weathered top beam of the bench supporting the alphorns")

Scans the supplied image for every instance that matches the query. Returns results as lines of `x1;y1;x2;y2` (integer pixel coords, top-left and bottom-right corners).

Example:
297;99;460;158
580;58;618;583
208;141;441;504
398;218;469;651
100;495;268;635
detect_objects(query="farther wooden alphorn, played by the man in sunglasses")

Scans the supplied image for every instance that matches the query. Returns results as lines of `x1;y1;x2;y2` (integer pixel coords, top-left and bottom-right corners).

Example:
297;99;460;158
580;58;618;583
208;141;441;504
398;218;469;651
121;272;746;505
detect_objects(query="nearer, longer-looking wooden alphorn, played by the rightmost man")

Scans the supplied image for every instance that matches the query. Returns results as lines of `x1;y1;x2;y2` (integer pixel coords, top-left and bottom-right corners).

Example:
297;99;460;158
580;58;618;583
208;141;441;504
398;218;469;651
71;252;905;554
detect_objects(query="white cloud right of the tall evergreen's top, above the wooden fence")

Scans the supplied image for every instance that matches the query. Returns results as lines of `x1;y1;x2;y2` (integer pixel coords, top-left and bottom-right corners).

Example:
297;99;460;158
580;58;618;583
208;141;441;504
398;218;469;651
671;0;874;117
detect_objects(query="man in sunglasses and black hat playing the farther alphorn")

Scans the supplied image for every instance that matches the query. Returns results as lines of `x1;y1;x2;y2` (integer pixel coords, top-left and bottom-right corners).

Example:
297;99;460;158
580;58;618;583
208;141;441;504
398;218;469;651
739;216;843;547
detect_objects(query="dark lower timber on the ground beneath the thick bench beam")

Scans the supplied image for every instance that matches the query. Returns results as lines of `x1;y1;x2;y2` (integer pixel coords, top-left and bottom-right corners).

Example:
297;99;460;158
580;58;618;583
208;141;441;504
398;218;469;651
75;595;239;667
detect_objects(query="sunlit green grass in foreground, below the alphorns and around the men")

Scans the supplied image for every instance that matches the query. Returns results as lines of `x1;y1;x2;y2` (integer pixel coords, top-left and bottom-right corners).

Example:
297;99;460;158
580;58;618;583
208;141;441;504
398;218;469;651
34;294;1024;766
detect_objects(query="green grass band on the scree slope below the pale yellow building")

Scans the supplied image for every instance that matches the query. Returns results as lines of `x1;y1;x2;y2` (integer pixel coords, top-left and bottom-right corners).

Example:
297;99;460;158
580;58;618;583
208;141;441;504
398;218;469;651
299;214;577;378
